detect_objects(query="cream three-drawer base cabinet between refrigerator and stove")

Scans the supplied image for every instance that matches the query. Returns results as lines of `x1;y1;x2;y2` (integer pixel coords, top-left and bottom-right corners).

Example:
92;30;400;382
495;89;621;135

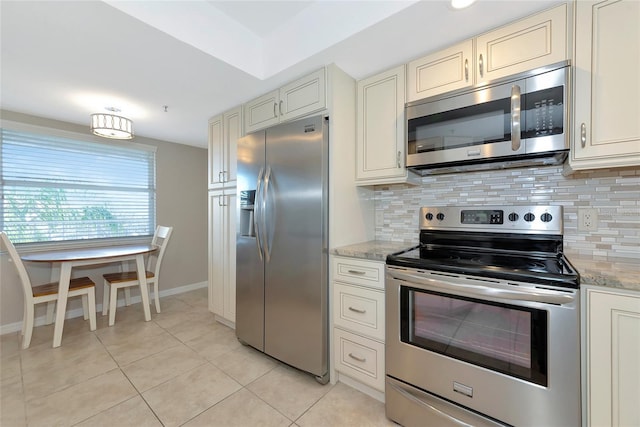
332;257;385;399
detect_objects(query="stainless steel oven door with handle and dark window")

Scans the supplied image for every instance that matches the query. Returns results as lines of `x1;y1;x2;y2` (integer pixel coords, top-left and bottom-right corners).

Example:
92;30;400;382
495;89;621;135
386;266;581;426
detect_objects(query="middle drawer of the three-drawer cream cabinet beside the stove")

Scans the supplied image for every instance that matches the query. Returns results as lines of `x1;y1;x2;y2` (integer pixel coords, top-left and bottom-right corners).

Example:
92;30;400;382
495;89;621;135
333;282;384;341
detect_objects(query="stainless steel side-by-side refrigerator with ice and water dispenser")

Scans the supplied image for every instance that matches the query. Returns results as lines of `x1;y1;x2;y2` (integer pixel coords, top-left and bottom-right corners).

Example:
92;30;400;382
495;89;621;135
236;116;329;383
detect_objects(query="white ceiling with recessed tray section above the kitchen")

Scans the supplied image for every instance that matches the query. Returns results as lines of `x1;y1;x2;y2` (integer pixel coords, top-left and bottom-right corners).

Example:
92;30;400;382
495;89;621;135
0;0;560;147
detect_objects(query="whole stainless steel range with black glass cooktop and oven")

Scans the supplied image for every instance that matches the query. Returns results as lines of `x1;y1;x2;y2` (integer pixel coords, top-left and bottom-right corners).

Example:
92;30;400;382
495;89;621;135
385;206;581;427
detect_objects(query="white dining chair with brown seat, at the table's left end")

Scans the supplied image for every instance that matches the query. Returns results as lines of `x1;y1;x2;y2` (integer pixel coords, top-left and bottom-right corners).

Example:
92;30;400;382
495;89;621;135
0;231;96;349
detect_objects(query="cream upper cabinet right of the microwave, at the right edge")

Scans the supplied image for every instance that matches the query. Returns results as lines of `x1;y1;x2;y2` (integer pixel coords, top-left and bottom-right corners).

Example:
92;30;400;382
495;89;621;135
569;0;640;170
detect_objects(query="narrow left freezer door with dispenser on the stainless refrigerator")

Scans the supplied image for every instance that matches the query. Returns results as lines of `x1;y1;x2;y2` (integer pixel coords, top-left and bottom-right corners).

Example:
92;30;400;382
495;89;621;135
236;131;265;351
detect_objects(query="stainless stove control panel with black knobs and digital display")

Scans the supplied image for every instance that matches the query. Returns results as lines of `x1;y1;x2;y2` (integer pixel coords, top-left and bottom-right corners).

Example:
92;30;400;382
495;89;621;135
420;206;563;235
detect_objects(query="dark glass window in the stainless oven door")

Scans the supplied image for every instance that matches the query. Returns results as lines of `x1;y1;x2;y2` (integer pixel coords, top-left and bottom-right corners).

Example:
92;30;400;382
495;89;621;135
401;286;547;386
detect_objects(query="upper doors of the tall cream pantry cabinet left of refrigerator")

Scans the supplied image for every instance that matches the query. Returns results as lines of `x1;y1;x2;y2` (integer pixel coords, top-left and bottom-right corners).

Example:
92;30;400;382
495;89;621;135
209;107;243;189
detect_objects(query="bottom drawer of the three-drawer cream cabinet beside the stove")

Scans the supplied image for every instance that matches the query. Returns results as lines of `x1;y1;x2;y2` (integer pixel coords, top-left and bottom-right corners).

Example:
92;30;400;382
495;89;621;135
333;328;385;392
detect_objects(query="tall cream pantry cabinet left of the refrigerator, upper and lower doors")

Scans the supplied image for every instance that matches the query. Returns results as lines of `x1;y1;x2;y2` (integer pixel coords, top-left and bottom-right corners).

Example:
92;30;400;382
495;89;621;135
208;107;243;326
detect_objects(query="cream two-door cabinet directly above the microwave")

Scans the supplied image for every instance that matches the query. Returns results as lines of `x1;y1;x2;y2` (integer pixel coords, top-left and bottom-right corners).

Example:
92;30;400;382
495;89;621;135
407;4;569;102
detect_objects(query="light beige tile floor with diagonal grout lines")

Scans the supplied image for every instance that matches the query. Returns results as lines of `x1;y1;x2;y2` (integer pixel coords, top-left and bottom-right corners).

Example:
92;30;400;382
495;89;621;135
0;289;394;427
